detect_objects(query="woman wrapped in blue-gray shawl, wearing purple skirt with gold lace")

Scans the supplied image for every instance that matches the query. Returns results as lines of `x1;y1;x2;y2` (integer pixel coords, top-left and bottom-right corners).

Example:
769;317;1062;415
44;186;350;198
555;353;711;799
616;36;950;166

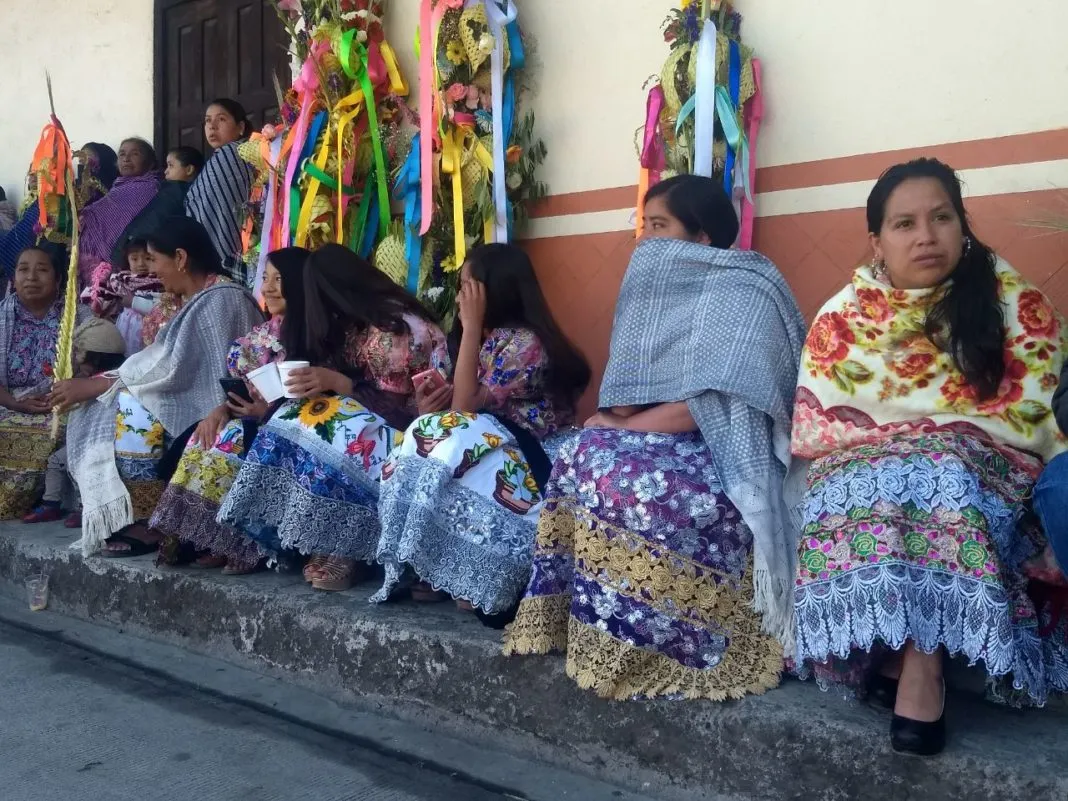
505;175;805;701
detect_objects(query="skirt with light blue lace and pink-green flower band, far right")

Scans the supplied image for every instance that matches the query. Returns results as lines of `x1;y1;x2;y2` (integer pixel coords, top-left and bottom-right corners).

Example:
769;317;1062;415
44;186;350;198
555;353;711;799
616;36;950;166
795;431;1068;705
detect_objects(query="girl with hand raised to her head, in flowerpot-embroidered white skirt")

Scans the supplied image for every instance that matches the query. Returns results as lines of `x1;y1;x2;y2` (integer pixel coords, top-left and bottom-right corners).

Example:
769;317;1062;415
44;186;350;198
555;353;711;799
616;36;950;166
375;245;590;615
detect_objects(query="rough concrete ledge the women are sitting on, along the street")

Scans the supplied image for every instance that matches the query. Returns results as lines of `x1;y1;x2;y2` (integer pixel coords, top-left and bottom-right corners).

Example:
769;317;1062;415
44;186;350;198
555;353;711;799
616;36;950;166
0;523;1068;801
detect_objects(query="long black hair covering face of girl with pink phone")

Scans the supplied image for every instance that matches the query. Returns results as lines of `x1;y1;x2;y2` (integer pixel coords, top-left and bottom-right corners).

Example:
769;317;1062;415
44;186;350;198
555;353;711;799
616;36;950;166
303;245;437;363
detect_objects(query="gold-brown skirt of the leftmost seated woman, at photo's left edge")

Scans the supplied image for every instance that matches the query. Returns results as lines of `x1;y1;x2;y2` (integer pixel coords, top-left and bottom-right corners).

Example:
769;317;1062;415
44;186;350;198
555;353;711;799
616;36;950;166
0;409;57;520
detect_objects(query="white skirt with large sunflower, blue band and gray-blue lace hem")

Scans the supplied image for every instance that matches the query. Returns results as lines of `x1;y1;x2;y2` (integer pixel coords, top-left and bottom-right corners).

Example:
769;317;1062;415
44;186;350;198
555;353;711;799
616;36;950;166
218;396;403;562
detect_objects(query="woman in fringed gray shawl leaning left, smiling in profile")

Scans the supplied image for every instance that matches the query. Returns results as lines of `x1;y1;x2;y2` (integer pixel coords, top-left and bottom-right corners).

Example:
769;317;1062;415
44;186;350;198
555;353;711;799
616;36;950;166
52;217;263;556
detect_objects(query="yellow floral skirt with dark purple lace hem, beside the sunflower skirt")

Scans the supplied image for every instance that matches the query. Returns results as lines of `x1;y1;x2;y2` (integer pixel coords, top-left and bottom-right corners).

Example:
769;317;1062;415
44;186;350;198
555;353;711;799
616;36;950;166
150;420;260;565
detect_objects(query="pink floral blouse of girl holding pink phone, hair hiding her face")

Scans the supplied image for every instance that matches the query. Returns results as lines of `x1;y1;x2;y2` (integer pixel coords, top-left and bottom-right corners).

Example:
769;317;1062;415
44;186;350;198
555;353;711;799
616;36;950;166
344;314;452;411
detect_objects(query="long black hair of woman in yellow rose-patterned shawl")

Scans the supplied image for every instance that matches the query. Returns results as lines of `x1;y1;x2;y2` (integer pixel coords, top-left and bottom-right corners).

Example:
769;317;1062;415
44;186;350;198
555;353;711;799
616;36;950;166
867;158;1005;401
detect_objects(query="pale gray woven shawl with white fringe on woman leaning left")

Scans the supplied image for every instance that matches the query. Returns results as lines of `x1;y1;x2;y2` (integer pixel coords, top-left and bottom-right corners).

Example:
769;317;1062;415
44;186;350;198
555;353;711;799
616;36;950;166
67;283;263;555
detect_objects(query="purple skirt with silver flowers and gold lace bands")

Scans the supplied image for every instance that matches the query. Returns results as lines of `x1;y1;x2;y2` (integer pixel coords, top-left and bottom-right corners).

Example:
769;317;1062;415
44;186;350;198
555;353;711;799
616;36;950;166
504;428;783;701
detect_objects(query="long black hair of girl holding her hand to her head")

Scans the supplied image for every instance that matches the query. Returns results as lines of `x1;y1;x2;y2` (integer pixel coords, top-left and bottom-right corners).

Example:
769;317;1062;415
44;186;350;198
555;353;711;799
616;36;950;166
467;244;590;404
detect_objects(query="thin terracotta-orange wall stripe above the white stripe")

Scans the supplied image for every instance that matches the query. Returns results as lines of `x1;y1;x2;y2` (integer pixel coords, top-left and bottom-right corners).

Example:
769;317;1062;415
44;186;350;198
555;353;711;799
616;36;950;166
531;128;1068;223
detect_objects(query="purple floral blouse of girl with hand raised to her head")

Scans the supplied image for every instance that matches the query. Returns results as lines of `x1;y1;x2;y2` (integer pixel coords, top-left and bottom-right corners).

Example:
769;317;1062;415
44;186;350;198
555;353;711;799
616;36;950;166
478;328;575;440
